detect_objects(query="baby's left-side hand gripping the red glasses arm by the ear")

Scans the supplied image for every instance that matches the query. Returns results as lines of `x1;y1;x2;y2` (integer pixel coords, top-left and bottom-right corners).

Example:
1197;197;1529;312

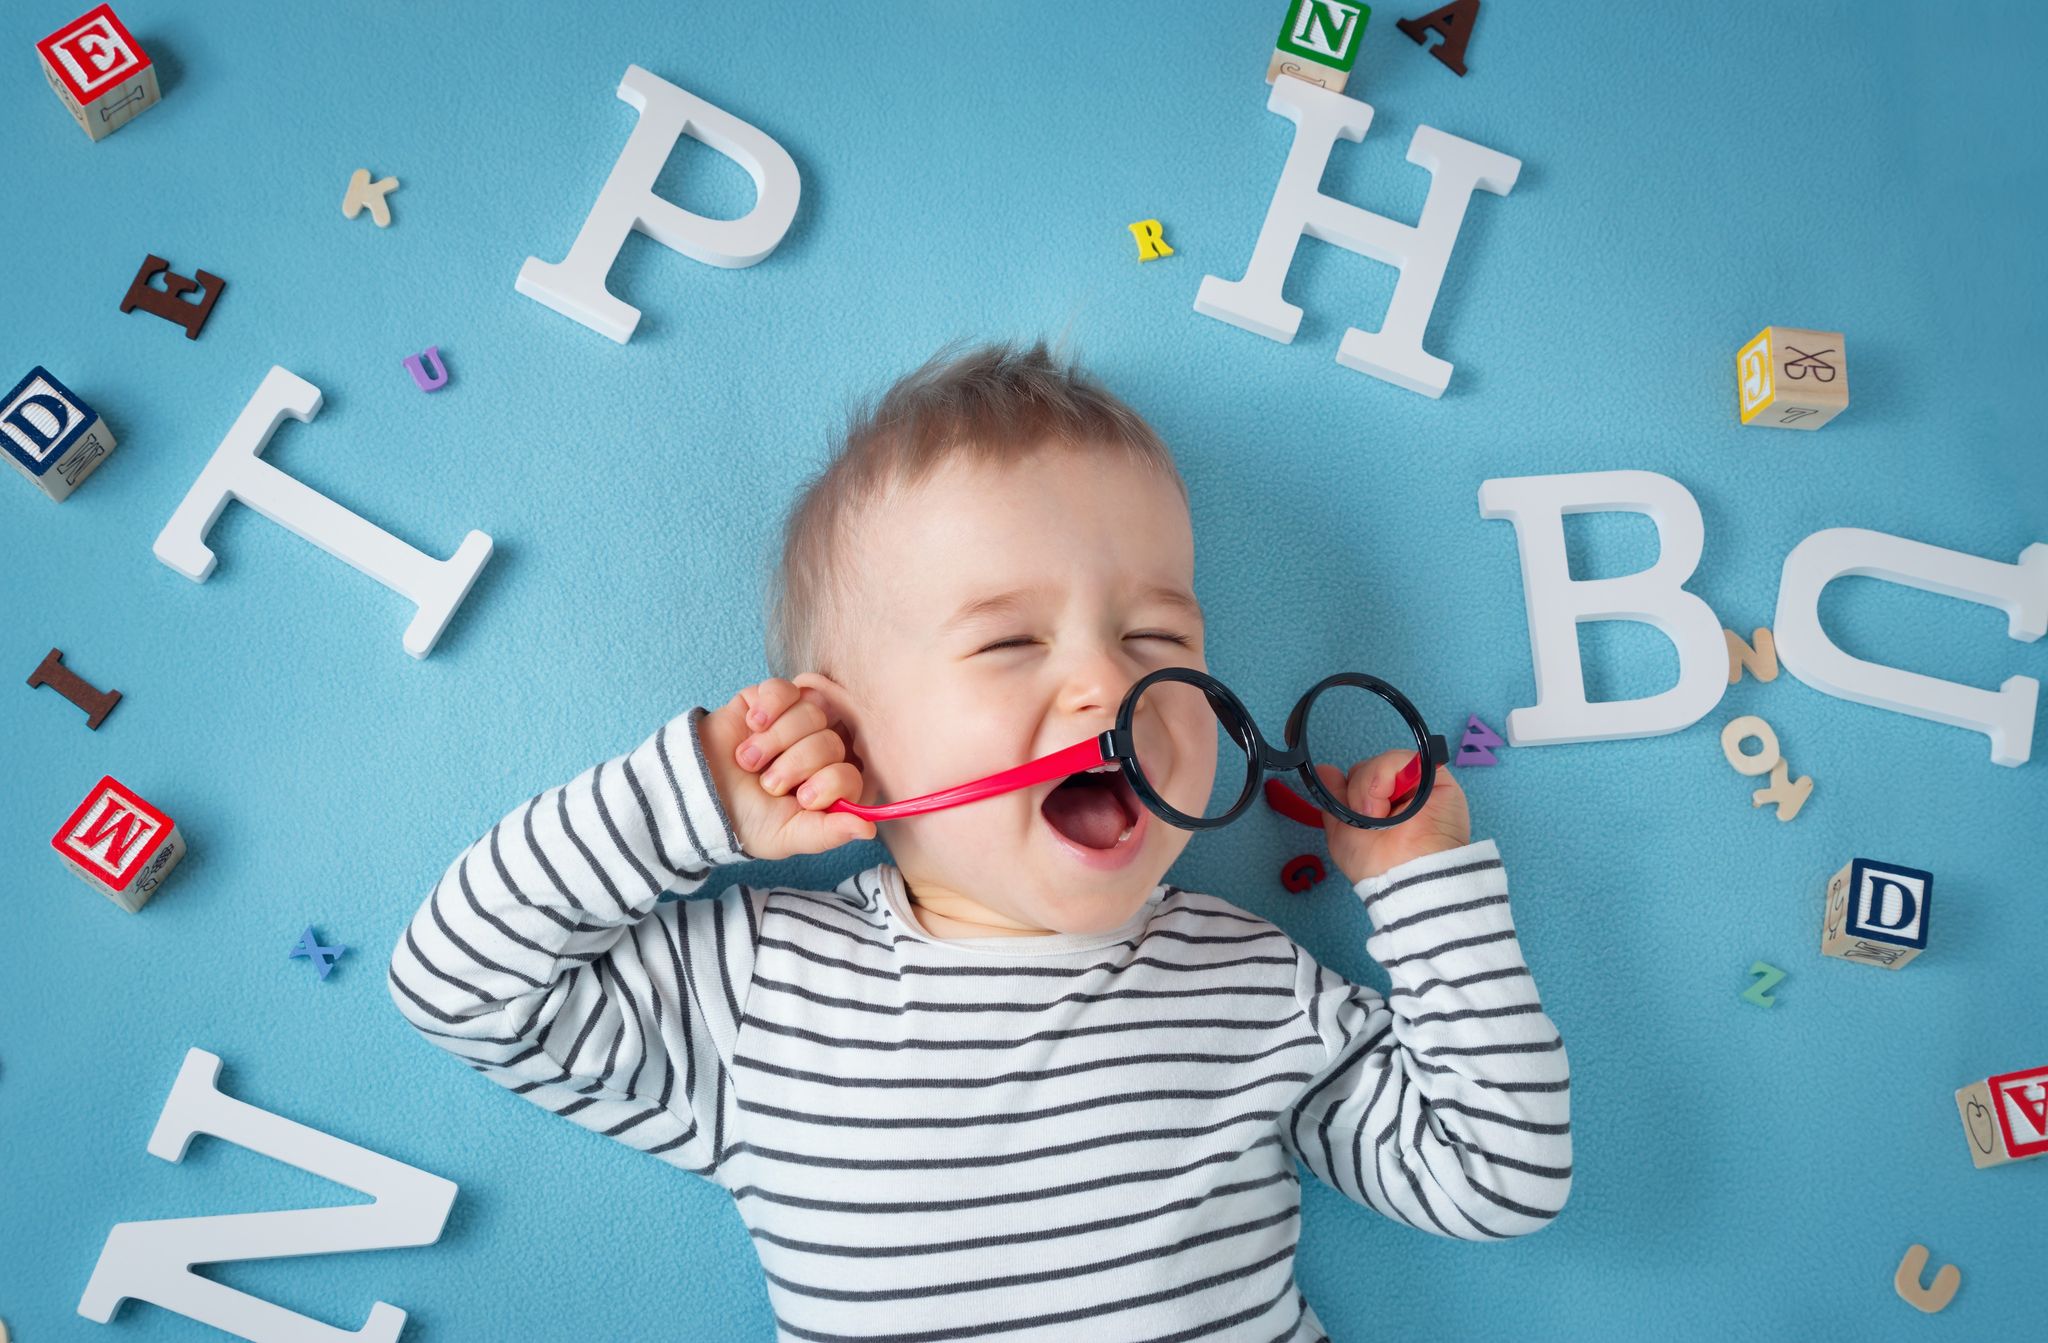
698;678;874;858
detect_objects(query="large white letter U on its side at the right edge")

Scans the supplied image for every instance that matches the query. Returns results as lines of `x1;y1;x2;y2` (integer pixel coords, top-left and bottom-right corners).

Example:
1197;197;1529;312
1772;526;2048;766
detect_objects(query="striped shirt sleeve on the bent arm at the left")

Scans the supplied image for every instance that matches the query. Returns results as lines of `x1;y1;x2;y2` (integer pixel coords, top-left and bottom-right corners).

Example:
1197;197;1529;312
387;706;766;1177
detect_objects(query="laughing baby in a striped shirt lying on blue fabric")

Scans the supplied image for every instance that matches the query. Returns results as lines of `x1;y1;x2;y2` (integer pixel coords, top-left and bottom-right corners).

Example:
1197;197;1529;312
389;342;1571;1343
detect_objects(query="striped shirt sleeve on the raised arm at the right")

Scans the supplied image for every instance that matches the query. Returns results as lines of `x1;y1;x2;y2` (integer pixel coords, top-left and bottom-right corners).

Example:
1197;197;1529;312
1280;839;1571;1241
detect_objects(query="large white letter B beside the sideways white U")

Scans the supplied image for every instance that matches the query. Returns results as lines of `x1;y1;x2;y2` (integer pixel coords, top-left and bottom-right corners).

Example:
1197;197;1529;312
1474;468;1728;745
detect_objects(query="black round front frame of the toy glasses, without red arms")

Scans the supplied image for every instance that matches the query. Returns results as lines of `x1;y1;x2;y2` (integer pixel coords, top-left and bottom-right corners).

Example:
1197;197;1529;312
1098;667;1450;829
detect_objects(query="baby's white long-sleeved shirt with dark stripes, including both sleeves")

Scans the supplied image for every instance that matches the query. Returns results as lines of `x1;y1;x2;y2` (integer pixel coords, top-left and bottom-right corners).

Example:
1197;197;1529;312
389;708;1571;1343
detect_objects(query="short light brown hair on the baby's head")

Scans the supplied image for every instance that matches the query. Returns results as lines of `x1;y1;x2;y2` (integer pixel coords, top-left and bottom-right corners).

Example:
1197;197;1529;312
766;340;1188;684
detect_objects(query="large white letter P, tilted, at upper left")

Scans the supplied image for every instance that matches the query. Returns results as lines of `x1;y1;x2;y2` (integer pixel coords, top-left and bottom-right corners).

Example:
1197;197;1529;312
516;66;801;344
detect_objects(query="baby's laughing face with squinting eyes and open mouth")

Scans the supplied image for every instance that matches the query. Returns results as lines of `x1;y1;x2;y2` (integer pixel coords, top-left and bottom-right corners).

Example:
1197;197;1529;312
811;446;1217;934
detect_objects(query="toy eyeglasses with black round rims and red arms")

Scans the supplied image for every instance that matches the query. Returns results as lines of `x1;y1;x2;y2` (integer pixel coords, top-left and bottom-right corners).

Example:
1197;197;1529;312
825;667;1450;829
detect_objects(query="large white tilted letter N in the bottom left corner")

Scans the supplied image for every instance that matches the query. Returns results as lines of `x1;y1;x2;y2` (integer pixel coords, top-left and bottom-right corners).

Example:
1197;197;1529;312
78;1048;455;1343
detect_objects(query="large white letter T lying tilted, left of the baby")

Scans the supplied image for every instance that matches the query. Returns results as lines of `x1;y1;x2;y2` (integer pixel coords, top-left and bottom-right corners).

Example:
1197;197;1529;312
156;366;492;657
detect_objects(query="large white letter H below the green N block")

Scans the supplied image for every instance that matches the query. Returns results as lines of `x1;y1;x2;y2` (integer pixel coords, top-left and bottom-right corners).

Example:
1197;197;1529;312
1194;78;1522;397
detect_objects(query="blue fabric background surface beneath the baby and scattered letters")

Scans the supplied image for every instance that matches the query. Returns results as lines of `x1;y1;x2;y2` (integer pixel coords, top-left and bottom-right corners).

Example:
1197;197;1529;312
0;0;2048;1343
